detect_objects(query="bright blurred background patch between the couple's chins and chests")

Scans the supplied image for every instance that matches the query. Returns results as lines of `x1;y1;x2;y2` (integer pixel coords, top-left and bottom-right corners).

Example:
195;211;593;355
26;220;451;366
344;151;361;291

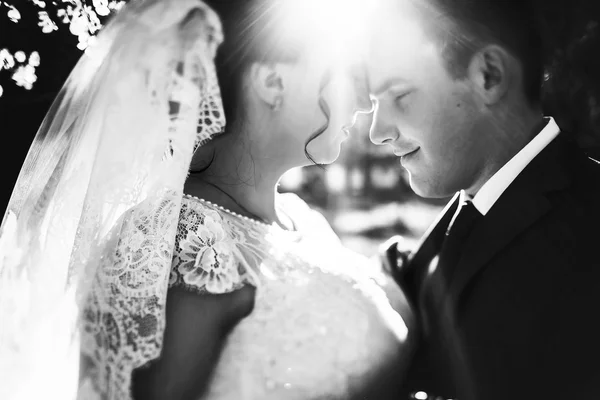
279;130;448;256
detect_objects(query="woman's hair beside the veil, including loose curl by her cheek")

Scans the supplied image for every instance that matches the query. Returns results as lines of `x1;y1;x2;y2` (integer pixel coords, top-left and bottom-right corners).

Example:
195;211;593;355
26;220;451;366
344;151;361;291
197;0;330;164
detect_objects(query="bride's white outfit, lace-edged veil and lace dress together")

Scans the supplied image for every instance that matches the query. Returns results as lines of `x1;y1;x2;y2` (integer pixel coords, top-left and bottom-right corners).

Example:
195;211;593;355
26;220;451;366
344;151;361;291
0;0;409;400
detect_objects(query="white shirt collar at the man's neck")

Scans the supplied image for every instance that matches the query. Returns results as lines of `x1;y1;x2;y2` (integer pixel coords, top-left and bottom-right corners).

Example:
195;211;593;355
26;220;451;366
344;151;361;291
468;117;560;216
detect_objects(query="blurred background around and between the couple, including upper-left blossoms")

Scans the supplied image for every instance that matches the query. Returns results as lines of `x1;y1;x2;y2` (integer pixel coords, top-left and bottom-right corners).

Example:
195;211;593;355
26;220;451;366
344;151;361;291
0;0;600;255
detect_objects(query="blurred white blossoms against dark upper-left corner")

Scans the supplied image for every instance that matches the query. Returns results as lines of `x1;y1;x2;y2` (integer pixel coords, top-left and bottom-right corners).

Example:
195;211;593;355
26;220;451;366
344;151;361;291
0;0;124;102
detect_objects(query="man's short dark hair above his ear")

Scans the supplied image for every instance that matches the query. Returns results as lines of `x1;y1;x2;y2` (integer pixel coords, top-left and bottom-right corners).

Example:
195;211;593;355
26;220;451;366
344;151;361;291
411;0;544;104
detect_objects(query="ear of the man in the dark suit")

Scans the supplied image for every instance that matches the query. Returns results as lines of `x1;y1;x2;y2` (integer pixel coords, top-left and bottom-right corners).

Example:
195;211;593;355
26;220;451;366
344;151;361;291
468;45;516;106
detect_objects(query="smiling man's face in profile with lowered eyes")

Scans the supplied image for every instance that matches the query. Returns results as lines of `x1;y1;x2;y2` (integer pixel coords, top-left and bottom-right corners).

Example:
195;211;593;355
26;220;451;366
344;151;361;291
368;10;484;197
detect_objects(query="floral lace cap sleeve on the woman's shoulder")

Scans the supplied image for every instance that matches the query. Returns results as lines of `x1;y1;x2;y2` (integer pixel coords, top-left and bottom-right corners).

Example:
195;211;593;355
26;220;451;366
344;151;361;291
169;202;251;294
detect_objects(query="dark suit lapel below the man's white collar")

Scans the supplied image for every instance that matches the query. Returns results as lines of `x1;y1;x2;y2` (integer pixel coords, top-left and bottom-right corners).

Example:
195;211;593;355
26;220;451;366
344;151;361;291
447;134;571;306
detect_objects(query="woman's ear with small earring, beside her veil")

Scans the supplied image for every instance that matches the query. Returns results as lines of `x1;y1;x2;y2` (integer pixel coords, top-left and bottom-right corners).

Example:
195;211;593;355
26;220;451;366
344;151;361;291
249;63;284;110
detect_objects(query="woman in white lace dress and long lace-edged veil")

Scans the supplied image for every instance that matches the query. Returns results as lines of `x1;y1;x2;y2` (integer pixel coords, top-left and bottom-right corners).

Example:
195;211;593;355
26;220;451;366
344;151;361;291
0;0;412;400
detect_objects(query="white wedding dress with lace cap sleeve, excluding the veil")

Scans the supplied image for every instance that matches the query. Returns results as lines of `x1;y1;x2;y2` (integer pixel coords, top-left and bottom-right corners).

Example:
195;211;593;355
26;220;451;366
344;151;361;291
170;194;408;400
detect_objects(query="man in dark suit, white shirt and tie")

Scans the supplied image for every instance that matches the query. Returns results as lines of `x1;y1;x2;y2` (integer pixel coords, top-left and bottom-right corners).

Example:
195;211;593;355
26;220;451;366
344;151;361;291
368;0;600;400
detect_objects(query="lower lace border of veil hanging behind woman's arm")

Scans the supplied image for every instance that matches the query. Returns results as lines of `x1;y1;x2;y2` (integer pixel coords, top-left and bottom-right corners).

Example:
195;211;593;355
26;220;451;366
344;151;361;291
79;192;181;400
